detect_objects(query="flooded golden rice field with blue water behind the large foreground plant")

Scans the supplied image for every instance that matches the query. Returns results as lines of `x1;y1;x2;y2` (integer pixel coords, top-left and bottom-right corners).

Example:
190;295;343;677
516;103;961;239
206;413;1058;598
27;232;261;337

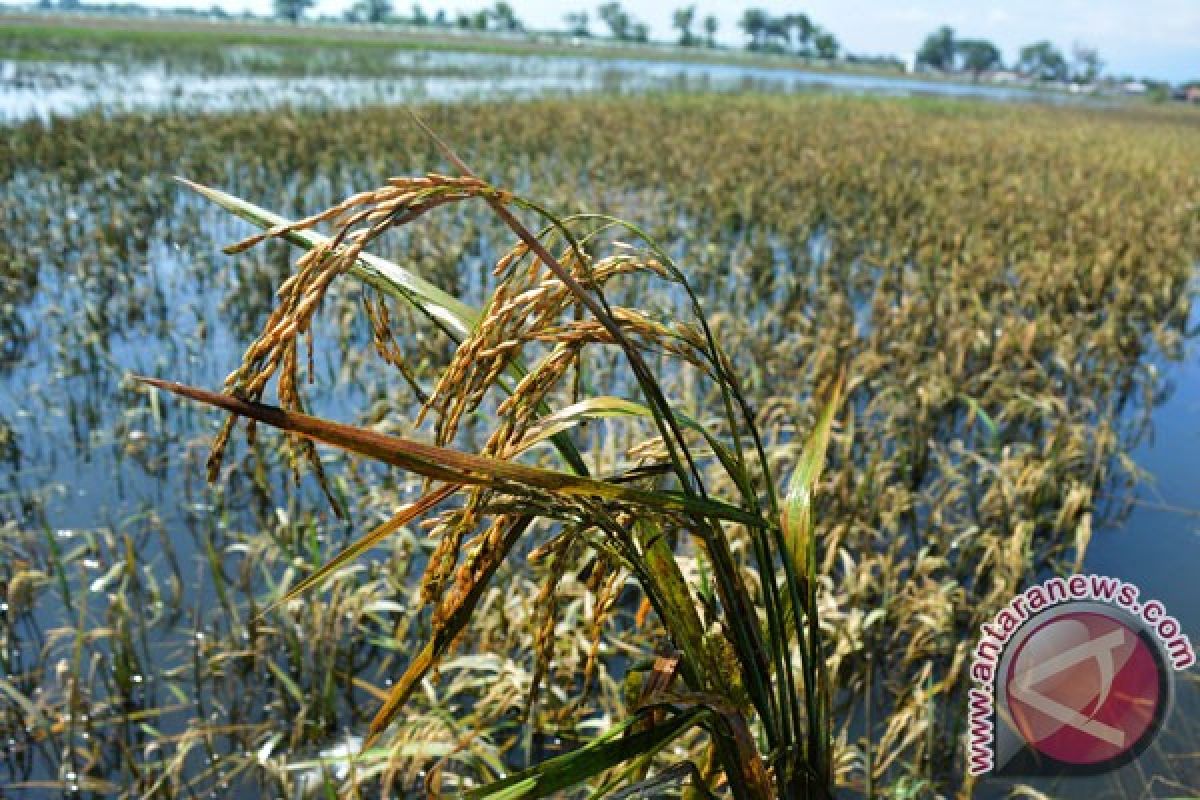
0;89;1200;798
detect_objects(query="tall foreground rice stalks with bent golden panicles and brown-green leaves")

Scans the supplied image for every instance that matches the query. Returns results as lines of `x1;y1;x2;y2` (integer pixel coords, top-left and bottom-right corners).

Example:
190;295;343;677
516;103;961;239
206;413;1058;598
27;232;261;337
152;128;838;798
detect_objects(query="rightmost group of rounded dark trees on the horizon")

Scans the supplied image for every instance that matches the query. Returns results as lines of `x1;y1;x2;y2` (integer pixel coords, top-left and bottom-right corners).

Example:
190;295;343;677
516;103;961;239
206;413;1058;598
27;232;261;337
917;25;1104;84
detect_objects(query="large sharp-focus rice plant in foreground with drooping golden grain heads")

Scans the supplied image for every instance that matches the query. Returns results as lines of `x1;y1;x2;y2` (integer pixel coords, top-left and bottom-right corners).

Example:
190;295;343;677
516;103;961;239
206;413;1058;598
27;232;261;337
143;128;841;798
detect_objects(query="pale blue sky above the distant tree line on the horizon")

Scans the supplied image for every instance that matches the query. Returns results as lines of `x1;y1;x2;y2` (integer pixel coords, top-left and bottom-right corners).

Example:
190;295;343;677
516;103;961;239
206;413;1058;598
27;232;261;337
131;0;1200;83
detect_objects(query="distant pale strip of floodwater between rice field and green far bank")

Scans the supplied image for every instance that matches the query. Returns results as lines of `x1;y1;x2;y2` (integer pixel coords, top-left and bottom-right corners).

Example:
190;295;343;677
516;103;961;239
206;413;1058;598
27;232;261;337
0;52;1097;121
